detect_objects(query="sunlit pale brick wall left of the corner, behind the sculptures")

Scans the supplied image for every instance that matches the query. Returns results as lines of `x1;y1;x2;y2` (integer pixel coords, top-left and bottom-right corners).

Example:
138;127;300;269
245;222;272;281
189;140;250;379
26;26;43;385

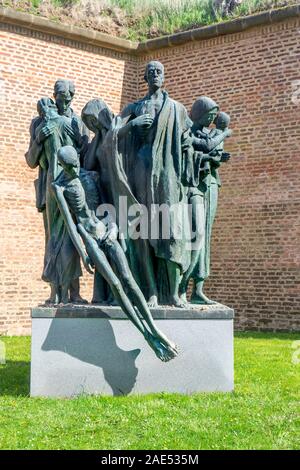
0;25;136;334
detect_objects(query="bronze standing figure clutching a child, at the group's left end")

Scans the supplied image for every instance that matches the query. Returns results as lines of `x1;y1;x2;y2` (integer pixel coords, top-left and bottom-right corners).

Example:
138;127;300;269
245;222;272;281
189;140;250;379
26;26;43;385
26;80;88;303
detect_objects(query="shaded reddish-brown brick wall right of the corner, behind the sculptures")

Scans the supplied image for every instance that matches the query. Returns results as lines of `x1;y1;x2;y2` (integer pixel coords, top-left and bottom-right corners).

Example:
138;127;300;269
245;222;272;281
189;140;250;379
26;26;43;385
139;14;300;330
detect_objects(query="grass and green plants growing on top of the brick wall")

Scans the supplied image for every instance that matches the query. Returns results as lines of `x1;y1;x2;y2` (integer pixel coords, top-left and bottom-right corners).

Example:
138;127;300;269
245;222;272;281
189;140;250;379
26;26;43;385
0;0;299;40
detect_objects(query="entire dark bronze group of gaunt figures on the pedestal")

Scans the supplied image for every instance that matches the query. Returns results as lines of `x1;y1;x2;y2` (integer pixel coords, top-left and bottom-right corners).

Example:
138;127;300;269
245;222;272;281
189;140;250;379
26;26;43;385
26;61;231;361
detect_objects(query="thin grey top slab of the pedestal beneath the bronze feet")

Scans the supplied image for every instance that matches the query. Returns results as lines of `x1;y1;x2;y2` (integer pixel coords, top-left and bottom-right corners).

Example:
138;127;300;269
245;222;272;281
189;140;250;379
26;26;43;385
31;303;234;320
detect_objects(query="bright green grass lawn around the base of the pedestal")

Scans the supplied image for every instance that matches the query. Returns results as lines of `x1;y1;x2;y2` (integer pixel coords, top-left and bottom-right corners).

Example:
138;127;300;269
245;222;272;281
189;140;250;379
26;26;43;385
0;333;300;450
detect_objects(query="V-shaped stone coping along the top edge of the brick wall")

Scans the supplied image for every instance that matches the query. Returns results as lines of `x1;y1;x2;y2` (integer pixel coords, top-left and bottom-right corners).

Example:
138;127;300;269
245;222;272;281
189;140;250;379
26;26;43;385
0;3;300;55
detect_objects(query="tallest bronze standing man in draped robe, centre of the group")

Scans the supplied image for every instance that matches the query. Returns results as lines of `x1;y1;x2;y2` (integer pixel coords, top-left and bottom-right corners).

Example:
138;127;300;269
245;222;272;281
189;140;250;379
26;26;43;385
121;61;191;307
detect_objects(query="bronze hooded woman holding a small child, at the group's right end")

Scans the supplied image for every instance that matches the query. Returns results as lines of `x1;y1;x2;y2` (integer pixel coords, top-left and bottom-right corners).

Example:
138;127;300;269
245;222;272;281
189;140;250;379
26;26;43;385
180;96;232;304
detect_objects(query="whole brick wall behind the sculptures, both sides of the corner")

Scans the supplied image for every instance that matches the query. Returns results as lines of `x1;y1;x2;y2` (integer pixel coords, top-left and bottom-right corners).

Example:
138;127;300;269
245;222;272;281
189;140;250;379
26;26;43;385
0;13;300;334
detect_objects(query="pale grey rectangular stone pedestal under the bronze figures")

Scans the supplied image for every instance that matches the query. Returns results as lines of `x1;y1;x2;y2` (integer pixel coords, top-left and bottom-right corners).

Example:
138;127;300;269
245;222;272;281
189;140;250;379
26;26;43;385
30;304;233;397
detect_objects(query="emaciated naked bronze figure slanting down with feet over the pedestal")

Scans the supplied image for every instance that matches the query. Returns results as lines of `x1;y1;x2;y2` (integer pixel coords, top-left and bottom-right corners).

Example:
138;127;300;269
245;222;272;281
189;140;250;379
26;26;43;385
52;146;178;361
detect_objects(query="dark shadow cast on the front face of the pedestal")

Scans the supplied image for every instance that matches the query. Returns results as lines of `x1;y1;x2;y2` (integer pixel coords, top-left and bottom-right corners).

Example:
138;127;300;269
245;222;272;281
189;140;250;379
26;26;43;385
42;318;140;396
